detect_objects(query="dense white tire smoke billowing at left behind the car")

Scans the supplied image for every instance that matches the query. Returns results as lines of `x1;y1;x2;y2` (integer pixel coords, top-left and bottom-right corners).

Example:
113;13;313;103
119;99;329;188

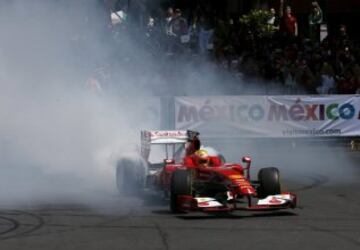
0;1;158;204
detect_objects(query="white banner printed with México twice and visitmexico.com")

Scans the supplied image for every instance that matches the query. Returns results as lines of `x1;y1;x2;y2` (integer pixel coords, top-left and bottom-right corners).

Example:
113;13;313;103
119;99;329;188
175;95;360;137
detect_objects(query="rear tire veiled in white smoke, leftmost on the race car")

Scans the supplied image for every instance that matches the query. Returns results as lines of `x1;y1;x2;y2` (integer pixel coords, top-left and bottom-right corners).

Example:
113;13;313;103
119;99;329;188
116;159;144;196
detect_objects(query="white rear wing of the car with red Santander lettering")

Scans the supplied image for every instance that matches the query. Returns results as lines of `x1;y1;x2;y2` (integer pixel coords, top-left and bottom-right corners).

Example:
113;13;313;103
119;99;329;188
141;130;199;159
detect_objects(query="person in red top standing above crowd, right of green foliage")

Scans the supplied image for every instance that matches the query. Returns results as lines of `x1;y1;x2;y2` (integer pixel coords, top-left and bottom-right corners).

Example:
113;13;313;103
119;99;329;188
280;0;298;38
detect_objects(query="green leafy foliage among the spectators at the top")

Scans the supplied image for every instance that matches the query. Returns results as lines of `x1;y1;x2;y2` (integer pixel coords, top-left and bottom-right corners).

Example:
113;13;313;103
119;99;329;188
239;9;276;39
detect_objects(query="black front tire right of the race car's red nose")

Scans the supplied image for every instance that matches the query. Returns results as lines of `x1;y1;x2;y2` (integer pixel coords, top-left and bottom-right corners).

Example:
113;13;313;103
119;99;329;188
258;167;281;198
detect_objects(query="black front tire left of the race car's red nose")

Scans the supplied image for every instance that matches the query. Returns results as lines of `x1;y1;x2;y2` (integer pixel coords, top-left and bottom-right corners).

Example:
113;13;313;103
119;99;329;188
170;170;192;213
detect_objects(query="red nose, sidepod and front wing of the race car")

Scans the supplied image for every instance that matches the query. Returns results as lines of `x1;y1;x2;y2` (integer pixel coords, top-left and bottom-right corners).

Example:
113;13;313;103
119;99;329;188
156;156;296;212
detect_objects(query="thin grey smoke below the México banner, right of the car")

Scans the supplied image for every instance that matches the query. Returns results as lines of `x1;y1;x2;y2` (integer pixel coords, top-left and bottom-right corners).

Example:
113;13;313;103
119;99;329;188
204;138;359;188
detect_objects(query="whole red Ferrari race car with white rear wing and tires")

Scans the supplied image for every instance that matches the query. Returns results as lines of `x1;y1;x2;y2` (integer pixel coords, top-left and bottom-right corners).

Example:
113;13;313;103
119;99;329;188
116;131;297;212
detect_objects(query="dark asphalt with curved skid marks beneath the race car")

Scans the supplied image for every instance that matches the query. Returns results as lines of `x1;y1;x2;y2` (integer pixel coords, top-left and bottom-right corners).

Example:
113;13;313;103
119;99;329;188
0;145;360;250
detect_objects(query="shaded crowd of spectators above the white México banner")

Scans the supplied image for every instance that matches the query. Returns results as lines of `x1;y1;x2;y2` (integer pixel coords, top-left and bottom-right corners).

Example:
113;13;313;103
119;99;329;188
98;0;360;94
